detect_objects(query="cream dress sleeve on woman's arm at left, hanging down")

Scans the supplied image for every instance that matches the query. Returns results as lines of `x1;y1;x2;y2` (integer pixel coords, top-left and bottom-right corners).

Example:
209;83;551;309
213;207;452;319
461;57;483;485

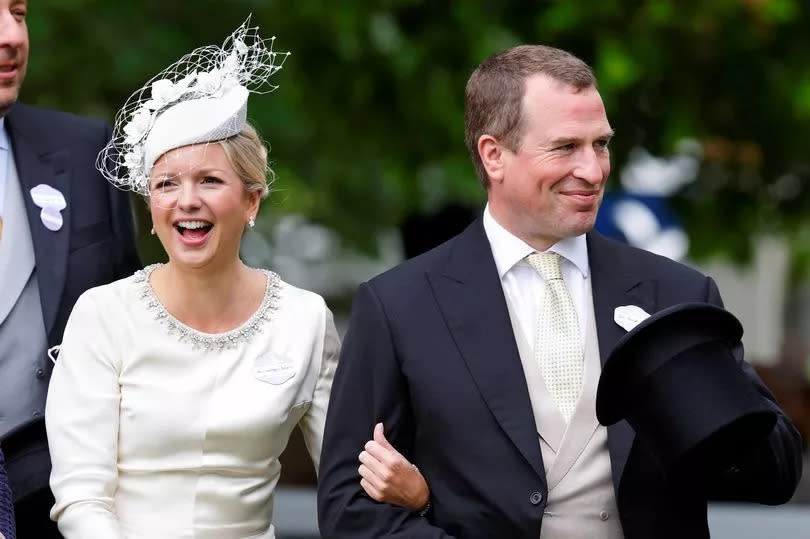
45;293;123;539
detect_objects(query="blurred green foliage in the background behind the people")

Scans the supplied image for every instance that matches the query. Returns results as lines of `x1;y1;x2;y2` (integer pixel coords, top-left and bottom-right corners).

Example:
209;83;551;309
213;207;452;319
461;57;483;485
23;0;810;277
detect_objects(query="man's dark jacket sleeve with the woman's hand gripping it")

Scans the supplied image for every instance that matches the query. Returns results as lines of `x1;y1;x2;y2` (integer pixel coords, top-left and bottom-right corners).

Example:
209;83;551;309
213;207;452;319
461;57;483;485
318;283;451;539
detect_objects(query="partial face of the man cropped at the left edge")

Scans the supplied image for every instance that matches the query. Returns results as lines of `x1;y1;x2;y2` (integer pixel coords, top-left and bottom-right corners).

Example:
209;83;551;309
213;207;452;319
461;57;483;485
0;0;28;115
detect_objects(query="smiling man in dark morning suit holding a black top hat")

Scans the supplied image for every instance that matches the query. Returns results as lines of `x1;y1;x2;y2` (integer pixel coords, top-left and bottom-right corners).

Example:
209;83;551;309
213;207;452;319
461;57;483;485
318;46;801;539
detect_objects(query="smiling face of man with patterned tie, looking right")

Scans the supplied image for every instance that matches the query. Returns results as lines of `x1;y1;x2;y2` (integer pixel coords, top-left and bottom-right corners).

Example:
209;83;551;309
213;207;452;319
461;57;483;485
488;75;613;250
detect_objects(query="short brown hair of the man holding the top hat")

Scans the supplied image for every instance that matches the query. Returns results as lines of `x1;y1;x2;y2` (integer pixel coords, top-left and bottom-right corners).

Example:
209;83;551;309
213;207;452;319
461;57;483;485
464;45;596;188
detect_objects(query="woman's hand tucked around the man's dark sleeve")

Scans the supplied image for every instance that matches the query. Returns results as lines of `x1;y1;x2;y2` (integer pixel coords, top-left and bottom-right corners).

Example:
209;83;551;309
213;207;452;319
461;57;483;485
359;423;430;511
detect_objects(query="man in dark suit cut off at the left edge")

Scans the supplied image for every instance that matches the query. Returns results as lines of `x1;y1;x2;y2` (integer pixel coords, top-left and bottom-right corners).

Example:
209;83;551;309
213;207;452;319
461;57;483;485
0;0;140;539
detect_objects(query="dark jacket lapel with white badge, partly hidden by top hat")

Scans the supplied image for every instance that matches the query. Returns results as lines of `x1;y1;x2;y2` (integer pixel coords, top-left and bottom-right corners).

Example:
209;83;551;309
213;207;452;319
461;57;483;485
588;233;657;491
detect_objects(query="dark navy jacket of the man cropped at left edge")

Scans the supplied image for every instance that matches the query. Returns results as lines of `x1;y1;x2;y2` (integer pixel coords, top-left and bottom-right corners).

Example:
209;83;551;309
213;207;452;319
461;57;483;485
0;104;140;499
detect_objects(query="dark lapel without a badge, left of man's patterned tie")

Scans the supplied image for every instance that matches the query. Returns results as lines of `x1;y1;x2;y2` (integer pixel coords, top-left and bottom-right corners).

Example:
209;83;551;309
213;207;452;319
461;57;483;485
428;219;545;482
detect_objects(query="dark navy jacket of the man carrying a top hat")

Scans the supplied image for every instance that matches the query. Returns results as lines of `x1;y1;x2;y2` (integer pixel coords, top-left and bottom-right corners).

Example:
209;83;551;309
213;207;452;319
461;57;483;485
318;219;801;539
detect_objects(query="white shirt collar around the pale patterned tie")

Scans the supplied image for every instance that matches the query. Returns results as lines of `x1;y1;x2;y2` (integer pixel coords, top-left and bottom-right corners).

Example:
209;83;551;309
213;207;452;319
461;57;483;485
484;204;588;279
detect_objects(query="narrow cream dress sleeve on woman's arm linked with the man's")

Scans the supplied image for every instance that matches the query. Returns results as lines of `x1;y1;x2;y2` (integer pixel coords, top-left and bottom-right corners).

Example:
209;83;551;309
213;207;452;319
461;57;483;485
299;304;340;471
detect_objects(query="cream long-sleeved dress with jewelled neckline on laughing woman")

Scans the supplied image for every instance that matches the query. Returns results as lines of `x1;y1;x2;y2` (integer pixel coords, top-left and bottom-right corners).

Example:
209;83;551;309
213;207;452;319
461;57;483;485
45;266;340;539
